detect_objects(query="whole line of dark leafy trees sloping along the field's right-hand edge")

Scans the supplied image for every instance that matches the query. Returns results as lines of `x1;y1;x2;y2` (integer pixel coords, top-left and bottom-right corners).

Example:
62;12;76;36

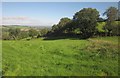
47;7;120;38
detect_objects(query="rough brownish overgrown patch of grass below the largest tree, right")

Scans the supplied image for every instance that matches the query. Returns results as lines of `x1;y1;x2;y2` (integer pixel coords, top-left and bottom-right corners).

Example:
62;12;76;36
86;39;118;58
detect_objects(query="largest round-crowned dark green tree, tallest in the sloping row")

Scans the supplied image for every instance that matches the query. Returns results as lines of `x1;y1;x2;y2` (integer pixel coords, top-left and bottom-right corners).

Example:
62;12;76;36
73;8;99;38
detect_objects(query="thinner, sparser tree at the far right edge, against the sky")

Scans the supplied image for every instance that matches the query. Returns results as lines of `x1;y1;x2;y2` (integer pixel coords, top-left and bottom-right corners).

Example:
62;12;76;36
103;7;118;36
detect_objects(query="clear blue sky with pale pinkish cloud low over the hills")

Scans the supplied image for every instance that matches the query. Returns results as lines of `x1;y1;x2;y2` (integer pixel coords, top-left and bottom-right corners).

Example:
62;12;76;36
2;2;118;26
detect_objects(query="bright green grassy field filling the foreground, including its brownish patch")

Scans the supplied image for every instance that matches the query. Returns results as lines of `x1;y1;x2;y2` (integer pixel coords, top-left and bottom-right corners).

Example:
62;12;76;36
2;37;118;76
